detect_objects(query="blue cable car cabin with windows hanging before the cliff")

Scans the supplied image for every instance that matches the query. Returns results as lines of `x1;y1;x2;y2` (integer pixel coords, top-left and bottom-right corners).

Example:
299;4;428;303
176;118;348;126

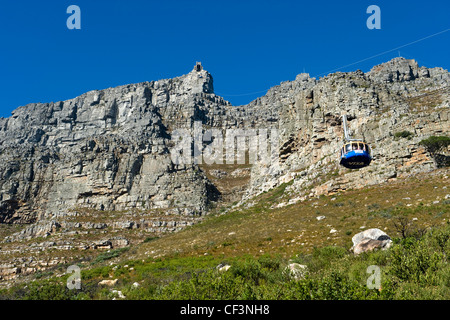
340;141;372;169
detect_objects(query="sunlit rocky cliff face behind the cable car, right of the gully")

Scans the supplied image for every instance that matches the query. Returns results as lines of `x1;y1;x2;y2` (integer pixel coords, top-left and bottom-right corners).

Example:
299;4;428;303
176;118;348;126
244;58;450;201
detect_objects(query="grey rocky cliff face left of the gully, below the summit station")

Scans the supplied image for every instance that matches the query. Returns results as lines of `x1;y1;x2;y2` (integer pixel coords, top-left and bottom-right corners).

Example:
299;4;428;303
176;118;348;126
0;63;230;223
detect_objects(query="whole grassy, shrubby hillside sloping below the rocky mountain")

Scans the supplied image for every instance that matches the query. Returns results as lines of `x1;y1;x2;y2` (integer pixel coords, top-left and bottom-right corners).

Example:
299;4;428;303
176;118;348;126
0;170;450;299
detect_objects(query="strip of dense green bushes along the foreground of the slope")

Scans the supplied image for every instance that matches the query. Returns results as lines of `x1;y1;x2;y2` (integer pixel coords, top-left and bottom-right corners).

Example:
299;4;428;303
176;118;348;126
0;224;450;300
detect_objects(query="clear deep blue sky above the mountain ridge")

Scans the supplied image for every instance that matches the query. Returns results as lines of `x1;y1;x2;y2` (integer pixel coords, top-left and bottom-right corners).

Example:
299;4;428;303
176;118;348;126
0;0;450;117
